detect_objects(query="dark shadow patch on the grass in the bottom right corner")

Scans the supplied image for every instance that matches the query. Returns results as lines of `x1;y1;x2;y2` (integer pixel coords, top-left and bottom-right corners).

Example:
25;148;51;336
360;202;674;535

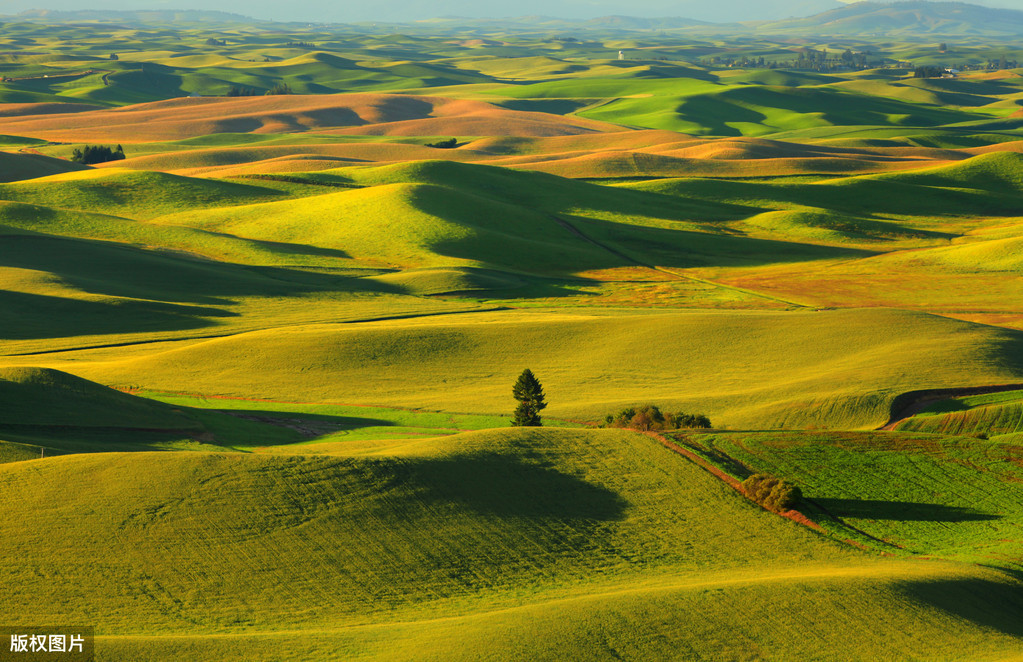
902;578;1023;637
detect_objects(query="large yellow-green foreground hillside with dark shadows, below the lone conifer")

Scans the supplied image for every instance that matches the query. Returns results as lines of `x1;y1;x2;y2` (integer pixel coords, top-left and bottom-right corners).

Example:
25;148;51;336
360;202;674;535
0;430;1020;660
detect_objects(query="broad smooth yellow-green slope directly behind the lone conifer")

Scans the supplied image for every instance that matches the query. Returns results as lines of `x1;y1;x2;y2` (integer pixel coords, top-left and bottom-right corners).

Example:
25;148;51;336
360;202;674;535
25;309;1023;429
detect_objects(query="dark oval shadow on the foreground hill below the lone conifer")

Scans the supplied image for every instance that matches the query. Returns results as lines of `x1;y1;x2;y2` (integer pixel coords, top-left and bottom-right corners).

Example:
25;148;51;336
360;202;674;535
407;453;628;521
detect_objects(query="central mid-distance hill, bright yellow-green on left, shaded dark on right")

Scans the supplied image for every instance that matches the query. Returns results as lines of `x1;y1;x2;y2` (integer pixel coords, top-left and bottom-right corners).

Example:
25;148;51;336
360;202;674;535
152;183;621;272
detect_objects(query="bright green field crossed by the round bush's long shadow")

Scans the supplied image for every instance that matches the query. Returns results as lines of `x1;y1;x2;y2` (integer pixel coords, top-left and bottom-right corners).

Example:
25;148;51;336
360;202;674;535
690;428;1023;572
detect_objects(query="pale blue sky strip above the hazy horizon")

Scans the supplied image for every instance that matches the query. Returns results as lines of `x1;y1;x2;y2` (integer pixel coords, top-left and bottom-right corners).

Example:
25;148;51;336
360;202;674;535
6;0;1023;23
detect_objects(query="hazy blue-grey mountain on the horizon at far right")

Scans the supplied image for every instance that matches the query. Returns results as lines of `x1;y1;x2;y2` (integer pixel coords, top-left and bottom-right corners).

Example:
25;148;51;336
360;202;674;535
755;0;1023;37
